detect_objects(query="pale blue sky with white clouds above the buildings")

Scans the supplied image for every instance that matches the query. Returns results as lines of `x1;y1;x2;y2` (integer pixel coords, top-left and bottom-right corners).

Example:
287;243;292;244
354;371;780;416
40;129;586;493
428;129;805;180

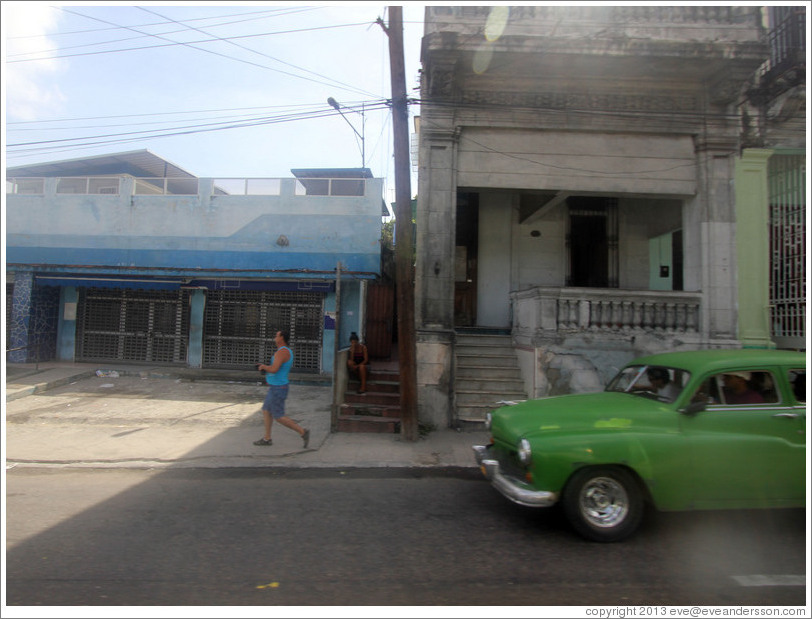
0;0;425;202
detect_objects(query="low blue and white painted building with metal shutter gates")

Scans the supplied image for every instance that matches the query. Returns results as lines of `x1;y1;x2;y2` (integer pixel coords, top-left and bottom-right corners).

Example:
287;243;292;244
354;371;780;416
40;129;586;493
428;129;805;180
6;151;388;374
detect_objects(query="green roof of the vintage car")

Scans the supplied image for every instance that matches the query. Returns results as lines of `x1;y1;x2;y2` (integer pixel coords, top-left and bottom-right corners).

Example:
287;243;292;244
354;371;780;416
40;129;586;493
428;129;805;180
628;348;806;372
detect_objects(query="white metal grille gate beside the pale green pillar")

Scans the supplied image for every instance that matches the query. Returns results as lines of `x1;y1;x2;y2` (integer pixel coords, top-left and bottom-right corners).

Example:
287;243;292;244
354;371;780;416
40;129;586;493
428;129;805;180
768;154;806;349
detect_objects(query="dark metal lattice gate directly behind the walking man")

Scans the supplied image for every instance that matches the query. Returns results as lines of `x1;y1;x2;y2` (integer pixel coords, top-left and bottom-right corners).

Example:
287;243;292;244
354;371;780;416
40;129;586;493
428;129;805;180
203;290;324;372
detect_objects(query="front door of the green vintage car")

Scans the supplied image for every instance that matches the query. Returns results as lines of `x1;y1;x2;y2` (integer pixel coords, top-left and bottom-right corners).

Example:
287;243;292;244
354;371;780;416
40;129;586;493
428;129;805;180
681;368;806;509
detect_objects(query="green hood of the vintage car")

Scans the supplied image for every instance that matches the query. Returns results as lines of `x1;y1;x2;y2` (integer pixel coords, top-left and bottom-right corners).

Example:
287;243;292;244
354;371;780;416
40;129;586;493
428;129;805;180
491;391;673;443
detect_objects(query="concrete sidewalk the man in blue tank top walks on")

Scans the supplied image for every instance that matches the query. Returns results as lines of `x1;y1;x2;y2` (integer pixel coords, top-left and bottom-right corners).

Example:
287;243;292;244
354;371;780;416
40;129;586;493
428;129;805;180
5;362;488;469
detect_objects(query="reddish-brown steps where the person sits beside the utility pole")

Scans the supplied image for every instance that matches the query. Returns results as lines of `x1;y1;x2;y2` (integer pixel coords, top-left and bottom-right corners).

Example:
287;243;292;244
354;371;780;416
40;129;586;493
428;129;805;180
337;368;400;434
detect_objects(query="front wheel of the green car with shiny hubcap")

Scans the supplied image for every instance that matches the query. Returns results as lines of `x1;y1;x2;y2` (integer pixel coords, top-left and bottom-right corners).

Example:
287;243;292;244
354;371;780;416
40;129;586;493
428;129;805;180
562;467;644;542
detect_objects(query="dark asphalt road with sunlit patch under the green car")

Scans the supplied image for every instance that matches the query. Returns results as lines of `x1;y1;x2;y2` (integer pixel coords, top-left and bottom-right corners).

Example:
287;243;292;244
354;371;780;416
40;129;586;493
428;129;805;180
5;468;807;616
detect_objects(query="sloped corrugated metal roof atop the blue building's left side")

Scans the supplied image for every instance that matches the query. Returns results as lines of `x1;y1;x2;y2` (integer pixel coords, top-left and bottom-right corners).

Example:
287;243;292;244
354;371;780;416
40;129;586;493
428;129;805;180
6;149;197;178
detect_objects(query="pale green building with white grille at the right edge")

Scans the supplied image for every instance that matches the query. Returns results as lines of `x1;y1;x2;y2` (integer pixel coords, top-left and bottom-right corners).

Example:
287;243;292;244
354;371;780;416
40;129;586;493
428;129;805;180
736;6;808;349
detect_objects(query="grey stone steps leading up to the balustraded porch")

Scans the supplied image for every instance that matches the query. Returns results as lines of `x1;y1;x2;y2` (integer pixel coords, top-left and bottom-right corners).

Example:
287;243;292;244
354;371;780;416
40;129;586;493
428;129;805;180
454;332;527;426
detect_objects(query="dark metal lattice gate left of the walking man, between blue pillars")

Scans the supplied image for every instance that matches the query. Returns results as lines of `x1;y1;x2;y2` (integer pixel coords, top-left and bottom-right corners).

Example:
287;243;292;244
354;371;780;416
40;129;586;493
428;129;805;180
76;288;189;364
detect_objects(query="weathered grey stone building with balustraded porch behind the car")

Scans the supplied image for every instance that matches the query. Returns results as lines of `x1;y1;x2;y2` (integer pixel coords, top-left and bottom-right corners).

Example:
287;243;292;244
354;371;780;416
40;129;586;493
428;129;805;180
415;4;795;426
